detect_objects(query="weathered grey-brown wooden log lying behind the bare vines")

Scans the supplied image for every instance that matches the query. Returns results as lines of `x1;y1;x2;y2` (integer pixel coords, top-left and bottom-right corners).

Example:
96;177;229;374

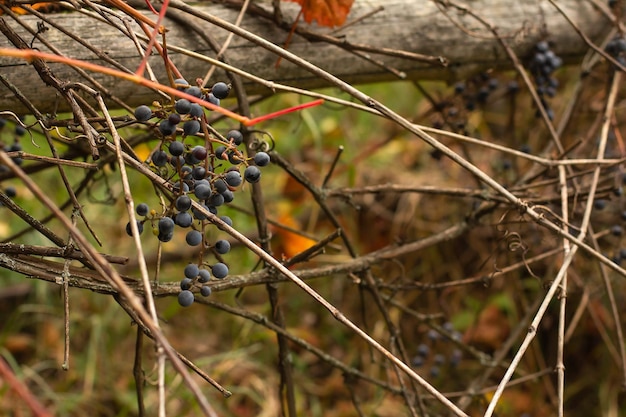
0;0;610;113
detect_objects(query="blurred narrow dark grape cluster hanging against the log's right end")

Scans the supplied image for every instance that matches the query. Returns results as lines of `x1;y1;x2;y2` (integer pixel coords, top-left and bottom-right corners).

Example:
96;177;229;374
528;41;563;120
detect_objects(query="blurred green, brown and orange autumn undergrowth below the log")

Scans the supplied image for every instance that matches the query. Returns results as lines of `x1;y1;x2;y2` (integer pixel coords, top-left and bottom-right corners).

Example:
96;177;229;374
0;0;626;417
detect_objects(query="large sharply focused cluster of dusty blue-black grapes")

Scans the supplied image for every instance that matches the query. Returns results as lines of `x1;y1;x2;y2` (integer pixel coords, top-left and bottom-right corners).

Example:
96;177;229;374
126;79;270;307
